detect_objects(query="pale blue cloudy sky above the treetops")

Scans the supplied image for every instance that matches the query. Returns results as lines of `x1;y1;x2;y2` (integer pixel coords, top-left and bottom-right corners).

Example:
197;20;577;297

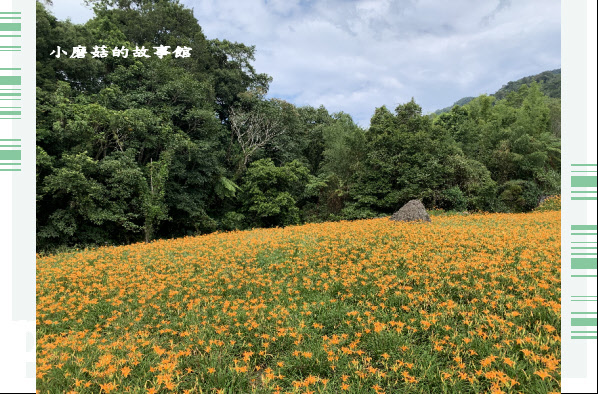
51;0;561;127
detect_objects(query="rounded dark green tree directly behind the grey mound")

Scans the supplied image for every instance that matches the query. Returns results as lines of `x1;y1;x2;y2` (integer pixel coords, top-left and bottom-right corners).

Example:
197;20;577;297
352;100;495;213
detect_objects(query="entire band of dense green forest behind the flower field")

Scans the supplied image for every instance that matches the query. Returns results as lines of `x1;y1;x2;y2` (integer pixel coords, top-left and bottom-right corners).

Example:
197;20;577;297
36;0;560;251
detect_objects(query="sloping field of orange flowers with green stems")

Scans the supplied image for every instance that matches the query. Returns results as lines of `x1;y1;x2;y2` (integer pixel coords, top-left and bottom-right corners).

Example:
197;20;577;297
36;212;560;393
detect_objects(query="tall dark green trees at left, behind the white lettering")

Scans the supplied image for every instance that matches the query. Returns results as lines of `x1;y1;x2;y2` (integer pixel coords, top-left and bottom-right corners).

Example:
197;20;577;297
37;1;258;249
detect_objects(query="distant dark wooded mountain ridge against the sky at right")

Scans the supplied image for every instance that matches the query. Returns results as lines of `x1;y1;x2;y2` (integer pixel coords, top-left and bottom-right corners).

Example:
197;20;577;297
434;68;561;115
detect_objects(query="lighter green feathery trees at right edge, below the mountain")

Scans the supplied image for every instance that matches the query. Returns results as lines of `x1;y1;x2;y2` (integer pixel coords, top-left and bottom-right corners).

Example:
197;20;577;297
434;82;560;212
